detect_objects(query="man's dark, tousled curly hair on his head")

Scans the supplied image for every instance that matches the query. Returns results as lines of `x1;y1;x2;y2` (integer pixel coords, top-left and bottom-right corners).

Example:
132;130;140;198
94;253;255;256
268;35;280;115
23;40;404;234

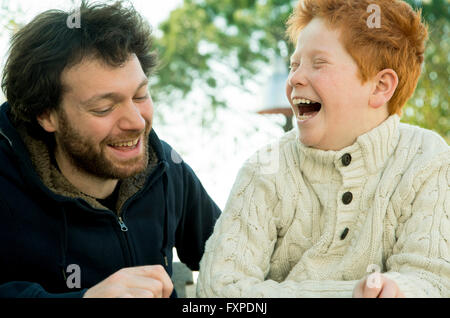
2;1;156;128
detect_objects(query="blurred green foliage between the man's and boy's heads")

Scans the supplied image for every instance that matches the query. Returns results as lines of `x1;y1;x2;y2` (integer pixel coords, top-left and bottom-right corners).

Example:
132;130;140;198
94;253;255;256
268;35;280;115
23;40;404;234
152;0;295;108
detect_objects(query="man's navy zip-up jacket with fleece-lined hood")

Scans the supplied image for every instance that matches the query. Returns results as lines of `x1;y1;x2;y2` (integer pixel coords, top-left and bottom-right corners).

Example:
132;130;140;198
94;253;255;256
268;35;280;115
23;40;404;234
0;103;220;297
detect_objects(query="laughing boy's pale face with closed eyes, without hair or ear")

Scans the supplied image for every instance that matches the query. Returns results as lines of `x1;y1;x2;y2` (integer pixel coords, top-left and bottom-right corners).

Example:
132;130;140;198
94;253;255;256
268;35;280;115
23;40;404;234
286;18;380;150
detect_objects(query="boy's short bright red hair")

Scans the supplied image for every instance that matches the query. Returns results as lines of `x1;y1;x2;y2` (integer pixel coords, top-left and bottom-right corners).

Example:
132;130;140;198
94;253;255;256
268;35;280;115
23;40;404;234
287;0;428;115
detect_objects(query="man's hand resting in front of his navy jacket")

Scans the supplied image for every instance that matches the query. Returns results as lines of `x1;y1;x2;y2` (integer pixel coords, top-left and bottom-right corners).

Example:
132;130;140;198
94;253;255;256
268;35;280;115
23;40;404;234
83;265;173;298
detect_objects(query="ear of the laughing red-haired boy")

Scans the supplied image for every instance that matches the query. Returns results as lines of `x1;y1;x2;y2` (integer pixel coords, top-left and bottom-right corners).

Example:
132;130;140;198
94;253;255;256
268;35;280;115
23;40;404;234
369;68;398;108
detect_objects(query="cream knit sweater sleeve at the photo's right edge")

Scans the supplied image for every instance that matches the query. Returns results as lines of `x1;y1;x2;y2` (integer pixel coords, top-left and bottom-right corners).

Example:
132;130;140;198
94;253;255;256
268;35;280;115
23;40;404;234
384;157;450;298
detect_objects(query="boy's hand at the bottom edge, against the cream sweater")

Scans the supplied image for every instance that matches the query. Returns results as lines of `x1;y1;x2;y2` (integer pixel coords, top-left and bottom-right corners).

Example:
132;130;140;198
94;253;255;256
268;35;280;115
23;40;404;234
353;273;405;298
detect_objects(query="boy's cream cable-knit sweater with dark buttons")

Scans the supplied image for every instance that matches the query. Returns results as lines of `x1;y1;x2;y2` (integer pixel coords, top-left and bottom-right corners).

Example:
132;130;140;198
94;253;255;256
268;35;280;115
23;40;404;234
197;115;450;297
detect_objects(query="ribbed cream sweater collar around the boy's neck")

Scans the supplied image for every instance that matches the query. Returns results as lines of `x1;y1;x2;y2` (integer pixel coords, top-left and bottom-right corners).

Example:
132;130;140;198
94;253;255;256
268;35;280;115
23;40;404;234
296;114;400;180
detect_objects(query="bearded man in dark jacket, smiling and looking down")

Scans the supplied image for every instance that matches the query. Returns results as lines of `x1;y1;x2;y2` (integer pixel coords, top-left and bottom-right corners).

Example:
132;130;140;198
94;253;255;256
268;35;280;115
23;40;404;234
0;3;220;297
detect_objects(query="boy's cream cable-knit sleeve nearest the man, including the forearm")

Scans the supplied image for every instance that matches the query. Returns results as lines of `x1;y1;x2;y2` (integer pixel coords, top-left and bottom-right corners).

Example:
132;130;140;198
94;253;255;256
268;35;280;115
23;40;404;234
197;162;356;298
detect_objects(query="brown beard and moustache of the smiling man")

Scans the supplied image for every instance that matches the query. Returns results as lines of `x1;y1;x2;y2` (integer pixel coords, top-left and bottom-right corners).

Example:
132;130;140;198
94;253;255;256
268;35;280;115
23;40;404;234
55;110;150;179
